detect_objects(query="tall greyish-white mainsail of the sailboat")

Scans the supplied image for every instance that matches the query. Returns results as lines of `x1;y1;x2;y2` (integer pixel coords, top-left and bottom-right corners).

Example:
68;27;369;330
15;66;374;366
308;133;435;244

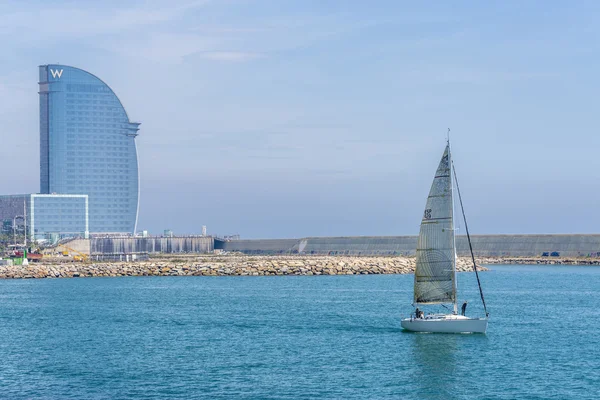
414;145;456;304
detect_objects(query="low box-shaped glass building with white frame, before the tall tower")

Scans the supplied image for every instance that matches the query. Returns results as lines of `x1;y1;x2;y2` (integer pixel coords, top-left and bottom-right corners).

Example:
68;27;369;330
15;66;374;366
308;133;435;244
0;194;89;240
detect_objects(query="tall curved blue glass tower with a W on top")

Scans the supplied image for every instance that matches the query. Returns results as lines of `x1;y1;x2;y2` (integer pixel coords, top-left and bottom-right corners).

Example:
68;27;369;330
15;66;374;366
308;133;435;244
39;65;140;233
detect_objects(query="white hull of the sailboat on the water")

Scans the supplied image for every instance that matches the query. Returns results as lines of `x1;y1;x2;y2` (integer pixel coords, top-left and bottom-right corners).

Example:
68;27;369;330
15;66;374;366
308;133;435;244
402;315;488;333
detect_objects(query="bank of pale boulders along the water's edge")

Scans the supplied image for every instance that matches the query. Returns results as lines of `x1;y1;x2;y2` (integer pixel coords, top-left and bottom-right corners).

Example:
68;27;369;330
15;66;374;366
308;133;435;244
0;254;600;279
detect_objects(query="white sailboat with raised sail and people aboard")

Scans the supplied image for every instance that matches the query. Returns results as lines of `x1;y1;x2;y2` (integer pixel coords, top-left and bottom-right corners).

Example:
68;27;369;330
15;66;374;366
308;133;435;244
401;140;489;333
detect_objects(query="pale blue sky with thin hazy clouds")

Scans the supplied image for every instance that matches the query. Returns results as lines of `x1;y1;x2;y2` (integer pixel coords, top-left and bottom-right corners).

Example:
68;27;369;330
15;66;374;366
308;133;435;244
0;0;600;238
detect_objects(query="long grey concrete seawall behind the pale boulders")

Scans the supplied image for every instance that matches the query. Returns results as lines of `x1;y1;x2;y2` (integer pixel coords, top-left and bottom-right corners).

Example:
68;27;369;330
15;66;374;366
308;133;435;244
56;235;600;259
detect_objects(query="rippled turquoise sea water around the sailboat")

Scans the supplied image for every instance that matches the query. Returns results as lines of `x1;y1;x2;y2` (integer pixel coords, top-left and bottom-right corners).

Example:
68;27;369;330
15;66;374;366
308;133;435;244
0;266;600;399
